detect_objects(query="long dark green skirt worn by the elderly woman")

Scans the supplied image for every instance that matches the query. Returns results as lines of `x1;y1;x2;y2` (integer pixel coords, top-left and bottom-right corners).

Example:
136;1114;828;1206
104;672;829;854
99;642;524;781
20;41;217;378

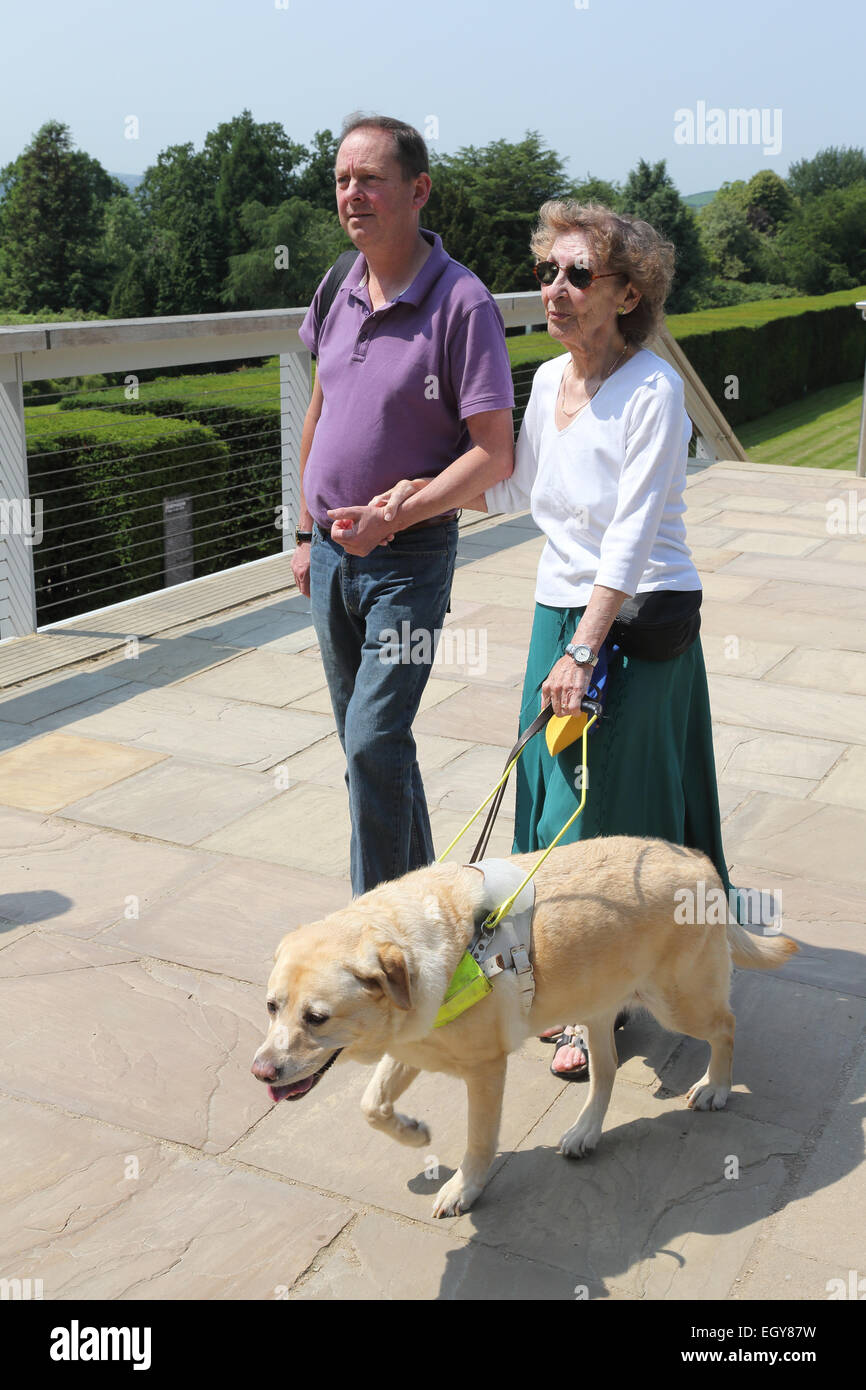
513;603;731;892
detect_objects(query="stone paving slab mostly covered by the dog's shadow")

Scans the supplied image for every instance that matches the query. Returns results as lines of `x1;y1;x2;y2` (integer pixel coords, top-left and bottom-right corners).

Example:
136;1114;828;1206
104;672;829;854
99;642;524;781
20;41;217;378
453;1080;801;1298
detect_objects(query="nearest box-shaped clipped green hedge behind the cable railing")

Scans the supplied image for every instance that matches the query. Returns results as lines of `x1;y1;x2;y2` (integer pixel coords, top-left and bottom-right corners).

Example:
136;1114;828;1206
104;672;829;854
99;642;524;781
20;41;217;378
26;407;229;623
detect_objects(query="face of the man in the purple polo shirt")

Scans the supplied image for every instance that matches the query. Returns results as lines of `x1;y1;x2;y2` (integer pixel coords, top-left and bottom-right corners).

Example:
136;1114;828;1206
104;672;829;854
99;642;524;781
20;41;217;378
336;129;430;252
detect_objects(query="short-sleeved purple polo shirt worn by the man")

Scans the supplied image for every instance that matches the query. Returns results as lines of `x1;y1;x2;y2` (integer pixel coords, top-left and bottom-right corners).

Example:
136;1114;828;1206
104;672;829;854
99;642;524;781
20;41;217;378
300;229;514;527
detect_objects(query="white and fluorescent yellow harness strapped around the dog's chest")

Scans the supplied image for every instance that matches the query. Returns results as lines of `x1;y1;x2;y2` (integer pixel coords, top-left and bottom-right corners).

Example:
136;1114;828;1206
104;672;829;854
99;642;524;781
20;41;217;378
434;859;535;1029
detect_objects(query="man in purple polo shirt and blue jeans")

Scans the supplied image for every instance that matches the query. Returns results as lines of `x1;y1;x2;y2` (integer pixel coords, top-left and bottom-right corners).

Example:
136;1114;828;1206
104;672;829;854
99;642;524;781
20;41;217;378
292;117;513;895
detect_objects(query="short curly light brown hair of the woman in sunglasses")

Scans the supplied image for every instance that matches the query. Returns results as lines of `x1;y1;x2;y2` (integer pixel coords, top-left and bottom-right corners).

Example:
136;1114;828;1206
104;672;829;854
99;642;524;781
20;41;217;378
530;199;674;346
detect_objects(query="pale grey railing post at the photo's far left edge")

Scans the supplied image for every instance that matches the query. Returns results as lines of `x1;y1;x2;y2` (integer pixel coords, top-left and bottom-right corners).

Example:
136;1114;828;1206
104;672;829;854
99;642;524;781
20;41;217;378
0;353;42;641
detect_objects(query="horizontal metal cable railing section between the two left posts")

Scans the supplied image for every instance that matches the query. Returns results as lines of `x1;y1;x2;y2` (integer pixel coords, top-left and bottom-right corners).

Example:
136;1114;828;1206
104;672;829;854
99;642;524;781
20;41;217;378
25;364;284;623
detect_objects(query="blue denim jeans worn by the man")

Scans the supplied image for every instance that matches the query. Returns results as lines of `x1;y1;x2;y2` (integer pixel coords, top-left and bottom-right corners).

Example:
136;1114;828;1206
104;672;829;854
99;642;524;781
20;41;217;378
310;520;457;897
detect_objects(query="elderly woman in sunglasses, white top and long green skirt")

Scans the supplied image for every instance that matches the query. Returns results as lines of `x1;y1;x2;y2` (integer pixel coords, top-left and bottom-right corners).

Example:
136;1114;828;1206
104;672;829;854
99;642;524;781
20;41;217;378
379;202;730;1080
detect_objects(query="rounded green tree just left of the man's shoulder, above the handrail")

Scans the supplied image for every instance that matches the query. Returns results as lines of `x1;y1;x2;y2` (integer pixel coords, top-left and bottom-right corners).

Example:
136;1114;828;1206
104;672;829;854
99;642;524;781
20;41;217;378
220;197;352;309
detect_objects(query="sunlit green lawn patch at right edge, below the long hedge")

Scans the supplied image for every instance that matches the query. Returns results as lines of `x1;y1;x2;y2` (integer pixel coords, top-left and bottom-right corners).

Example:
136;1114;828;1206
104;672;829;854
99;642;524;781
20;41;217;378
737;379;863;471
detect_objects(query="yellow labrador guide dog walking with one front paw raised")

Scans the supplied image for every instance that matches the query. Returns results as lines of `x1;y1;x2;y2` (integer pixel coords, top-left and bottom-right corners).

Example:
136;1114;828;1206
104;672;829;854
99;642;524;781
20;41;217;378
253;835;798;1216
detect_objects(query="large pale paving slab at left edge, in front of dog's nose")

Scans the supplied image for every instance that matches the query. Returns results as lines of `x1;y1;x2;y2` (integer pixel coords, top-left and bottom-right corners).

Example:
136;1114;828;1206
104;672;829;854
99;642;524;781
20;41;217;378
0;942;271;1154
